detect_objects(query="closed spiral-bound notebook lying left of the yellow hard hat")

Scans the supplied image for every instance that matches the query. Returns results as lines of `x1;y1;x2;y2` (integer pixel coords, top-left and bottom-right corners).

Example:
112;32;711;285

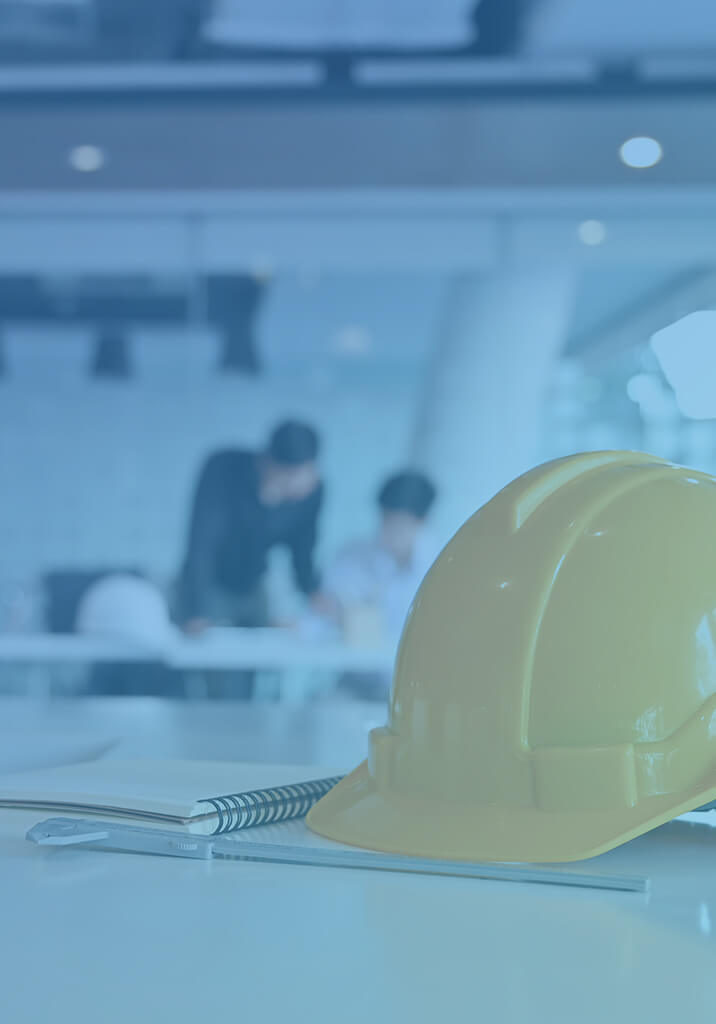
0;760;341;836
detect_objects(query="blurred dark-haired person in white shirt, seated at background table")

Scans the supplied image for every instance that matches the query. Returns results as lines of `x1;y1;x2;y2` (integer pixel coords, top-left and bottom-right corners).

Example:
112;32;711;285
315;470;439;696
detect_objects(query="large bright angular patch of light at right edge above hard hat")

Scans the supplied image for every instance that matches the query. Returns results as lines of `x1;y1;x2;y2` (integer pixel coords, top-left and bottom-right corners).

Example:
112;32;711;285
651;310;716;420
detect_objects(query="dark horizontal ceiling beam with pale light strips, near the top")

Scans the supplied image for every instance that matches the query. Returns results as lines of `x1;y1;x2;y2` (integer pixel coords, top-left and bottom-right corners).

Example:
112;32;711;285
0;61;716;110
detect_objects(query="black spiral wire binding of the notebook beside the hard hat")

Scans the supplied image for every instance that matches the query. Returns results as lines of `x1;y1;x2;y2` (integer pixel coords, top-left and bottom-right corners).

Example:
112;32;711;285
201;775;343;836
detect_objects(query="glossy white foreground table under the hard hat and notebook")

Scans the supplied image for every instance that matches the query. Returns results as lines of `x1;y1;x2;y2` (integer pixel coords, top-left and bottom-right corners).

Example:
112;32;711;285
0;699;716;1024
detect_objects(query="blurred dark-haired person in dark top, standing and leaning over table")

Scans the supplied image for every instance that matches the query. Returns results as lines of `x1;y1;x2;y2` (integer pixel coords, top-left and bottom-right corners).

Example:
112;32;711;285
177;420;324;632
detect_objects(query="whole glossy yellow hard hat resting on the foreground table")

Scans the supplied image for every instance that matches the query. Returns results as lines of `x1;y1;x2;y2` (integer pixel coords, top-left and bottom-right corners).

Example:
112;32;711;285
308;452;716;861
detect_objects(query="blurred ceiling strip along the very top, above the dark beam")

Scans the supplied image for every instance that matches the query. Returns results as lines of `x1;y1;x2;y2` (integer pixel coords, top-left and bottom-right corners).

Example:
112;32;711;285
0;0;716;70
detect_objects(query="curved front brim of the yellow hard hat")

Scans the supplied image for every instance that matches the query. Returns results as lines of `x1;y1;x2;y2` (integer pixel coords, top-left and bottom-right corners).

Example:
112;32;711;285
306;761;716;863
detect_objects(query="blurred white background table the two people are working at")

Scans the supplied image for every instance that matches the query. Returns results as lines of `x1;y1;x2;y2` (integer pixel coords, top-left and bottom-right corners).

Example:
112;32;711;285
0;629;394;695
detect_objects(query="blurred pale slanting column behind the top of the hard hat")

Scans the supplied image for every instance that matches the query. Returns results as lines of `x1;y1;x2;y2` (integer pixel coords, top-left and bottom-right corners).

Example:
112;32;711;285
413;266;574;537
